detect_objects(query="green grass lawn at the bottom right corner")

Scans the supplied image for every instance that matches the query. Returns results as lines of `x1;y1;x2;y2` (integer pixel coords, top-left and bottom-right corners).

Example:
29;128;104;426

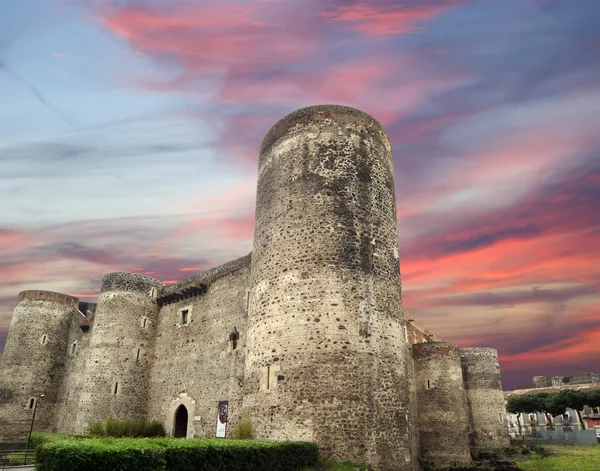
517;445;600;471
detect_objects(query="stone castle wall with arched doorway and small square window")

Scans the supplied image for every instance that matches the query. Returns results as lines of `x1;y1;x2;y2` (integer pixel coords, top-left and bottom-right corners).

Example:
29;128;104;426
148;256;250;437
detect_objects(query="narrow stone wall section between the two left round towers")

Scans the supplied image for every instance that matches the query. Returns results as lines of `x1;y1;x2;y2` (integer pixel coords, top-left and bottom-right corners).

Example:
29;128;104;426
53;303;96;434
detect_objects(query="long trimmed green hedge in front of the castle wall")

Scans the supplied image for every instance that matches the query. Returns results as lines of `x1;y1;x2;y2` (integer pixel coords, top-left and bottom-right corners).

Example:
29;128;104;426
36;438;318;471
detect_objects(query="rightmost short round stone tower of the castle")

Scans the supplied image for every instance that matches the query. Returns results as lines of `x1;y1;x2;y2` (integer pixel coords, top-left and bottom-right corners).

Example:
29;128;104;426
460;348;509;452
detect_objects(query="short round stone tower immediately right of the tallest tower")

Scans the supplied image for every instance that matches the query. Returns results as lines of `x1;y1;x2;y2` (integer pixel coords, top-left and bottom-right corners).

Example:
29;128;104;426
413;342;471;469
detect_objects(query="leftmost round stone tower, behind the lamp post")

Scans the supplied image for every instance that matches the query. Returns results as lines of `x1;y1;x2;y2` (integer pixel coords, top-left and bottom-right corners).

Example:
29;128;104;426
0;290;77;441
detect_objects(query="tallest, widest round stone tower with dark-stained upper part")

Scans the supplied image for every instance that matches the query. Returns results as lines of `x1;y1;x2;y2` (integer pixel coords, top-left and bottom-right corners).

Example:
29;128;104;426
244;105;413;471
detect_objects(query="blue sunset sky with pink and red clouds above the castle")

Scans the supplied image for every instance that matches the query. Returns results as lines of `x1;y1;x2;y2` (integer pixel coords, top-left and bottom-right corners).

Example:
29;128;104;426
0;0;600;389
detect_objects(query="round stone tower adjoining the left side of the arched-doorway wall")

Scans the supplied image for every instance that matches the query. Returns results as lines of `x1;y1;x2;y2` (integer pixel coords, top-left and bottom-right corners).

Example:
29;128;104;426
77;273;162;433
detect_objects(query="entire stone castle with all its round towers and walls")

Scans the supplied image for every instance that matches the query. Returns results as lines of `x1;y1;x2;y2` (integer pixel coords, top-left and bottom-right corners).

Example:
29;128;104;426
0;105;508;471
